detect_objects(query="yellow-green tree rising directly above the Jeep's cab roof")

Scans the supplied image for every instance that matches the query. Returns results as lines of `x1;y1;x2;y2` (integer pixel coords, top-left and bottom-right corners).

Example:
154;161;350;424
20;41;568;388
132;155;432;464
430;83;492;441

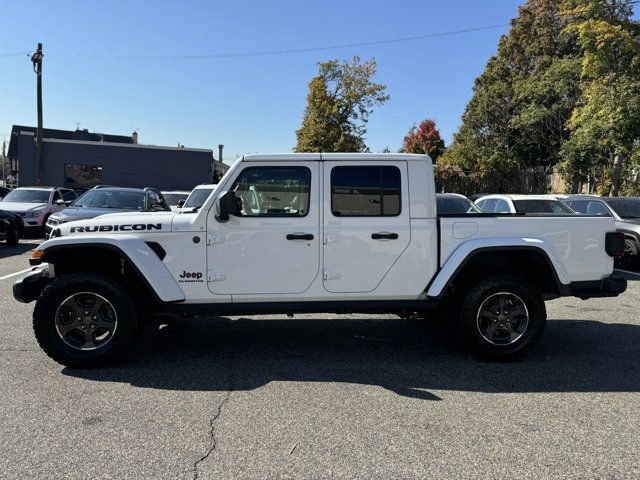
294;56;389;152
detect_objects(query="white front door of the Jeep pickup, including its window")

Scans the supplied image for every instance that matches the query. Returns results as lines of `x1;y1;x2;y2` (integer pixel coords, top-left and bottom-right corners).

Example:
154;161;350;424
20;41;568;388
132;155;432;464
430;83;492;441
207;161;321;295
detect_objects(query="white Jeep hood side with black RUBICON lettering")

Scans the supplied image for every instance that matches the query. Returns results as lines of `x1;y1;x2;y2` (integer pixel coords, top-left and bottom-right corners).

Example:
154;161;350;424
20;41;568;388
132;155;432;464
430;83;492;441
58;212;173;236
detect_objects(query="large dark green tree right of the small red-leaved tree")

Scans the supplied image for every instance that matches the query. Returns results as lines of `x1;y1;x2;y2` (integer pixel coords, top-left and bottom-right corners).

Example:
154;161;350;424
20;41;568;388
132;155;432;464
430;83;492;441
443;0;580;183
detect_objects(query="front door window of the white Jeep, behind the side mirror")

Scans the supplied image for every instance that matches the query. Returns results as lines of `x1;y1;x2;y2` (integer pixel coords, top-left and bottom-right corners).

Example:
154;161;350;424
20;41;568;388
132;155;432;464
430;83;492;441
231;167;311;217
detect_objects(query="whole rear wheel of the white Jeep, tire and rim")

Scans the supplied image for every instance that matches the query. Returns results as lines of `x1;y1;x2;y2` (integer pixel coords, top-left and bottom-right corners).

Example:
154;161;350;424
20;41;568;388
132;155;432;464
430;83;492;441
460;275;547;360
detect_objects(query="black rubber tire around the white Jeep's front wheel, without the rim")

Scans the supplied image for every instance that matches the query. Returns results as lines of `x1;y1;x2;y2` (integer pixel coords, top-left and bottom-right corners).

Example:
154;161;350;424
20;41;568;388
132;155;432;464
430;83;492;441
33;272;141;368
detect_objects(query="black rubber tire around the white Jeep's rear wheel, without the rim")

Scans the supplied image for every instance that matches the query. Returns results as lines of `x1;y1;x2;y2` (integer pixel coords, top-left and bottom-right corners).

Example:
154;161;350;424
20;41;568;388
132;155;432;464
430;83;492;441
458;275;547;361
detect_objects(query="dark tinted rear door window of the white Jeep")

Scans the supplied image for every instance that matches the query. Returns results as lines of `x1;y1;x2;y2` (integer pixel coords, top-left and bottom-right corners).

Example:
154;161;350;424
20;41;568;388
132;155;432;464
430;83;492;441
331;166;401;217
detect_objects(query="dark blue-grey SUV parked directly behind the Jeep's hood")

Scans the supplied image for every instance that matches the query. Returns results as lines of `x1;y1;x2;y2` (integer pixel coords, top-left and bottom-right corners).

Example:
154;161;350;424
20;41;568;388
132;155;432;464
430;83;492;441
45;185;171;238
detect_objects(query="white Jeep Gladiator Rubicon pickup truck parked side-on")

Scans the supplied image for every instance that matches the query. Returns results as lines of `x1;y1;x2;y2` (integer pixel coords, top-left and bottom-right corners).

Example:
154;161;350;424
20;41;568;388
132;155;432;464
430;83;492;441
14;153;626;367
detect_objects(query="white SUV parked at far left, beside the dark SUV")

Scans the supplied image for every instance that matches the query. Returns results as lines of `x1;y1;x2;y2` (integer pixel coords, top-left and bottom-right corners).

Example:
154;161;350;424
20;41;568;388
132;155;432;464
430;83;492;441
0;187;78;231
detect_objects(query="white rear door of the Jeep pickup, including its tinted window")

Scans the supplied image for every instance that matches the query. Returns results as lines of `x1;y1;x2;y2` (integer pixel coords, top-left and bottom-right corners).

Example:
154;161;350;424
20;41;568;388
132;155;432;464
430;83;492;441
323;161;410;293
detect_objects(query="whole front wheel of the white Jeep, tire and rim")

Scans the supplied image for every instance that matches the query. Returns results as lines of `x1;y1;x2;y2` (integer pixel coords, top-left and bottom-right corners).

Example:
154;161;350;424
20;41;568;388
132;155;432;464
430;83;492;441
33;273;140;368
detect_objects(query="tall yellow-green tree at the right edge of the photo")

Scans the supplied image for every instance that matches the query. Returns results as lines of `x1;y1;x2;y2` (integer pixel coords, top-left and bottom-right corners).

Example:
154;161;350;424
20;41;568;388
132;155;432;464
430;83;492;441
562;0;640;195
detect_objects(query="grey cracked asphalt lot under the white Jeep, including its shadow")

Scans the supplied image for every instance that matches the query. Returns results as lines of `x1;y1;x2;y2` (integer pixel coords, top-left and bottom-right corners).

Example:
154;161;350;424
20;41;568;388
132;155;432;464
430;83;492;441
0;245;640;479
